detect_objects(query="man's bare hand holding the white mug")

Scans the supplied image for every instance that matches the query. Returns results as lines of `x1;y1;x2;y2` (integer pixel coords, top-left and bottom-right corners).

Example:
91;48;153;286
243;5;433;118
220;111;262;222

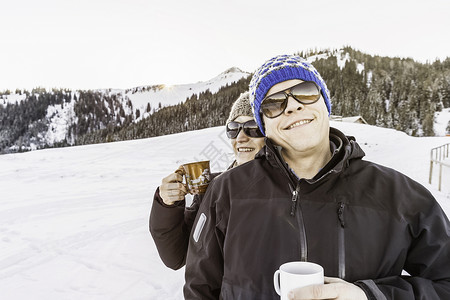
288;277;367;300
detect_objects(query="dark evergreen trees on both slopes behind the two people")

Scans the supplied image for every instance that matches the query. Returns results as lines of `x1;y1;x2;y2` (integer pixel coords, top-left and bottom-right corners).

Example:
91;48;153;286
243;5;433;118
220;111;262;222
0;47;450;153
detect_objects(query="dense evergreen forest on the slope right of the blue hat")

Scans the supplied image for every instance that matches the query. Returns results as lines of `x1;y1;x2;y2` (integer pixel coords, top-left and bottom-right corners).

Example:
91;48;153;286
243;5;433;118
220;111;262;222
300;47;450;136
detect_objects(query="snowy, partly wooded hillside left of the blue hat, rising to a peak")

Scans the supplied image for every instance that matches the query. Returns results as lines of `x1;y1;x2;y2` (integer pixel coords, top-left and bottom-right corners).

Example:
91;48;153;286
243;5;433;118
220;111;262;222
0;68;250;153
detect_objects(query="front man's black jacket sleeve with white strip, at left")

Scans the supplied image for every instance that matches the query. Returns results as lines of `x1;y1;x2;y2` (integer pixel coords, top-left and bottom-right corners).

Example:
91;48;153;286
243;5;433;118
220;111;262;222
184;182;224;299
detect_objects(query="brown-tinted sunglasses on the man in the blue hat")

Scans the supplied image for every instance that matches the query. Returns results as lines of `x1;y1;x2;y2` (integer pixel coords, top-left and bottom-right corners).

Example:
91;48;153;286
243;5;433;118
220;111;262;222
260;81;320;119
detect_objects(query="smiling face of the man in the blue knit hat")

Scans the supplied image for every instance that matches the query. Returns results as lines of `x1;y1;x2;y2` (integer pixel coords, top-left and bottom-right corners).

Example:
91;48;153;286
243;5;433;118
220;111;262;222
263;79;330;154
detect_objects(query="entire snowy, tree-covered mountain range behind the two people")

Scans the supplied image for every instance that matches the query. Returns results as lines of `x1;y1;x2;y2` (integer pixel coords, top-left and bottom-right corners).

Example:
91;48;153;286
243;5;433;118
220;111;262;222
0;47;450;153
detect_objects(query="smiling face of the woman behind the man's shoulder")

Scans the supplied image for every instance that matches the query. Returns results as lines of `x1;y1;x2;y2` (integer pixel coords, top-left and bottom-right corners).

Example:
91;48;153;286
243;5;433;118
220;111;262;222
231;116;264;165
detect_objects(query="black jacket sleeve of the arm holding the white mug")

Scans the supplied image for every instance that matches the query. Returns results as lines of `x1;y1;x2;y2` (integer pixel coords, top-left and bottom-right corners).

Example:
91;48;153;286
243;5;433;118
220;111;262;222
356;199;450;300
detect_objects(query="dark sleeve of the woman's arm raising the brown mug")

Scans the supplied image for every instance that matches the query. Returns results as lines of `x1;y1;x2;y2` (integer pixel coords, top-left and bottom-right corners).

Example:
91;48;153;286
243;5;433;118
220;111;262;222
149;187;192;270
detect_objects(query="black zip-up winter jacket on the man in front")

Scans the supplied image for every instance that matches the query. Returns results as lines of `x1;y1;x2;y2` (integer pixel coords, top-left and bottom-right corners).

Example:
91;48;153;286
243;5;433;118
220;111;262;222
184;128;450;300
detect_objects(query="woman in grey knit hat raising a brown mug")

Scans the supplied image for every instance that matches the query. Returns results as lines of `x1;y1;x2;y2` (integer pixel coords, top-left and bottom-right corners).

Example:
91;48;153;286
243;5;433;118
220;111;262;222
150;92;264;270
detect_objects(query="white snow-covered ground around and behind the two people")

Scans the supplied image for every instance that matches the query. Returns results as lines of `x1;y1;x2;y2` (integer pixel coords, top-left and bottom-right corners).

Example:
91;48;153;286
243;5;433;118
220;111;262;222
0;122;450;300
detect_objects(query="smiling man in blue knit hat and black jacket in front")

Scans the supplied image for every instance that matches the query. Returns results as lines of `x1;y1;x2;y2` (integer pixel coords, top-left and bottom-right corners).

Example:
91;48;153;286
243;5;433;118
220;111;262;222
184;55;450;300
